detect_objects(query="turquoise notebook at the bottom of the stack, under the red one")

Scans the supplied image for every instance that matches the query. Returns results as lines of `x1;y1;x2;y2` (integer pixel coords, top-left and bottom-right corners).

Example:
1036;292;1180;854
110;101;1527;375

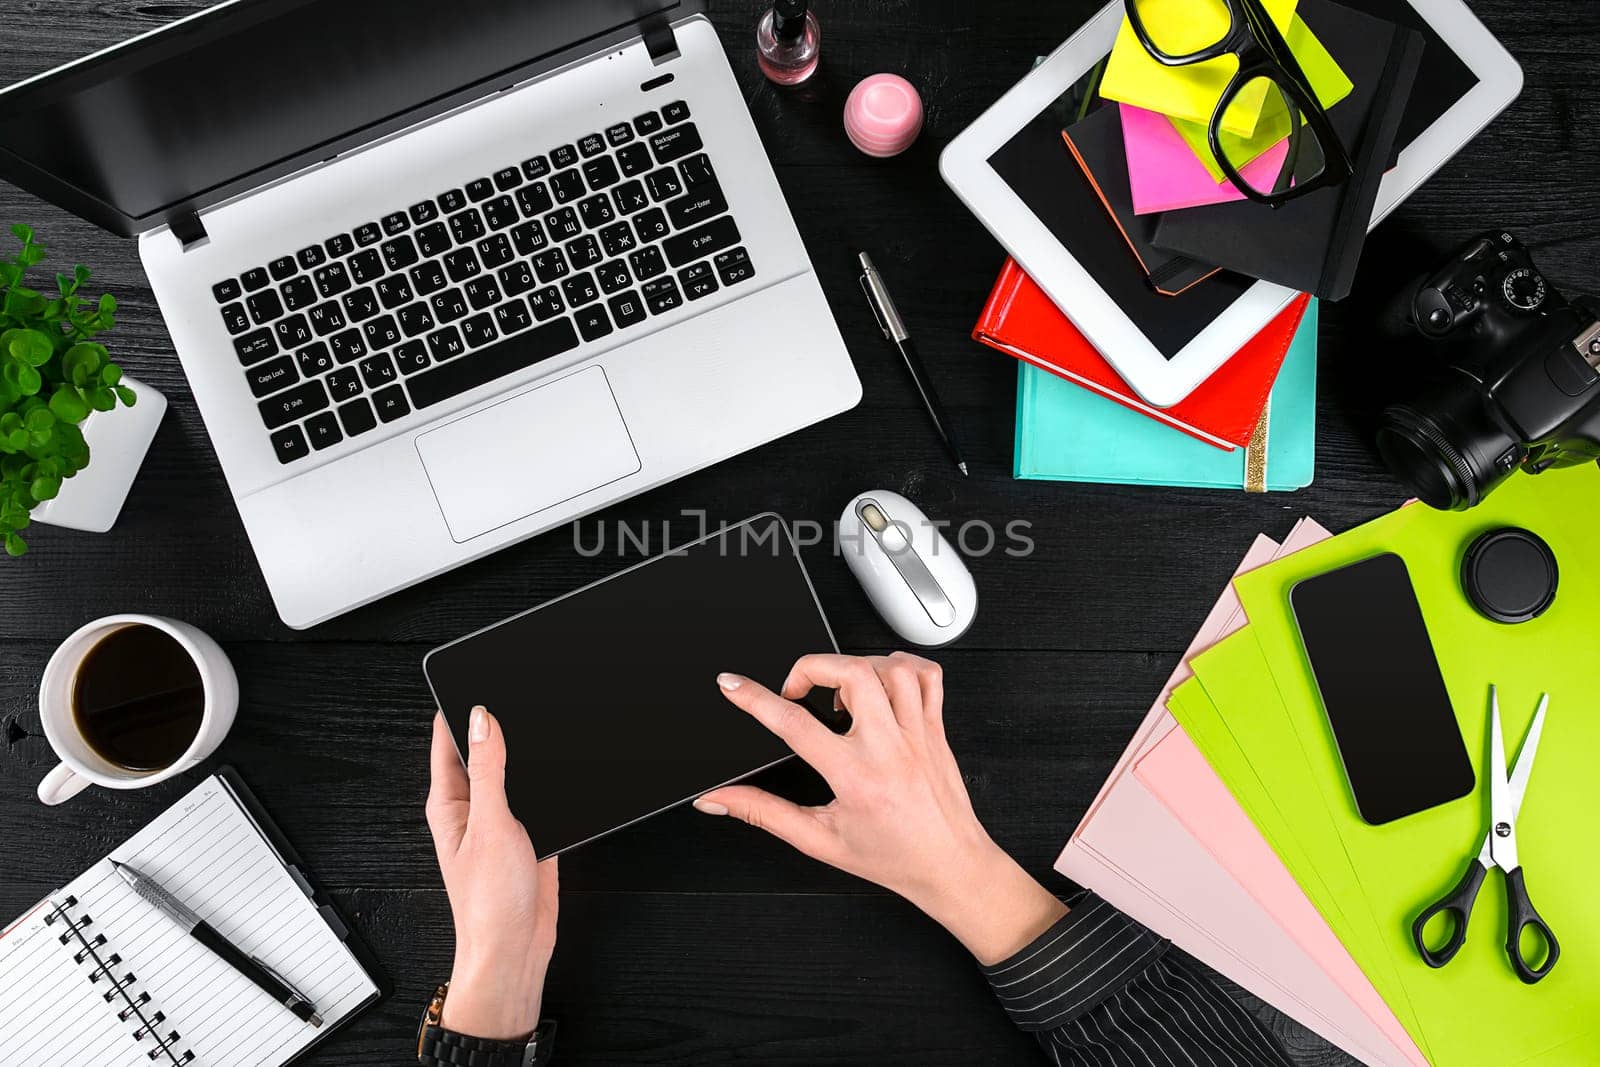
1014;301;1317;493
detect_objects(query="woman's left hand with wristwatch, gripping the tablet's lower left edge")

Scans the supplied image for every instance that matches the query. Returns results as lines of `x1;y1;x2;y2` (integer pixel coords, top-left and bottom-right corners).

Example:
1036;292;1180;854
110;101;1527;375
427;707;560;1041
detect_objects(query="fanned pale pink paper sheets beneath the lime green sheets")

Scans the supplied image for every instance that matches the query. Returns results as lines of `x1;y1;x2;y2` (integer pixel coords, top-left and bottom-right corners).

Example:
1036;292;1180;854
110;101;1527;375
1056;522;1427;1067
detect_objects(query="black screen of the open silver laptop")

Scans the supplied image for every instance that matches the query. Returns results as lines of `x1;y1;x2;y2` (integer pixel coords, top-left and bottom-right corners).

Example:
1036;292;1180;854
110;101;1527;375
0;0;685;232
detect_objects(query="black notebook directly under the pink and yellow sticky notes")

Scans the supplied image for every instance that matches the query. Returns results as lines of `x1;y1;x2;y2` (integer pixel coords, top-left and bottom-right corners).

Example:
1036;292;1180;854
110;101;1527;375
1154;0;1424;301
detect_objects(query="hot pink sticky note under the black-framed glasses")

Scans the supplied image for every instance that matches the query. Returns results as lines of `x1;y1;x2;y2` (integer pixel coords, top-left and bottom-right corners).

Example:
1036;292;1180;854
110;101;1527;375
1118;104;1290;214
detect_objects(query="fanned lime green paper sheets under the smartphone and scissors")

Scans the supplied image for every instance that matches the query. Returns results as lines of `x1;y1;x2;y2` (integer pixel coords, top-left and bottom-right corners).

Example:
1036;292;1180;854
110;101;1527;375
1171;466;1600;1067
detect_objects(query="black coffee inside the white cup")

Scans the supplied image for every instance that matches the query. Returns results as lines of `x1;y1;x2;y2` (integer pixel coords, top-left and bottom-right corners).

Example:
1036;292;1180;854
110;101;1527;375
72;625;205;771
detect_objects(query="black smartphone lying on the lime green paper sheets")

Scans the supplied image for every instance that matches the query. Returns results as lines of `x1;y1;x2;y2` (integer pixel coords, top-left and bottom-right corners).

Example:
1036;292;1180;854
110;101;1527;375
1290;553;1477;825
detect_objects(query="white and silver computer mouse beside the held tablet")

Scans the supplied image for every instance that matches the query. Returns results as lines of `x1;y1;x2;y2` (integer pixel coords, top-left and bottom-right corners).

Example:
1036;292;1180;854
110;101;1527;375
838;490;978;648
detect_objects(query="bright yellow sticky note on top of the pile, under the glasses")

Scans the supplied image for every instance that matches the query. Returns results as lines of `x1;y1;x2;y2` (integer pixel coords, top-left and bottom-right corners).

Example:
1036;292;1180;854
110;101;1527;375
1101;0;1298;139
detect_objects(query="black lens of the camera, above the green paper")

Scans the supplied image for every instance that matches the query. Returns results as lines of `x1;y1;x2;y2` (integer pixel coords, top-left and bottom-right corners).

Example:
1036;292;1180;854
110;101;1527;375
1378;390;1522;512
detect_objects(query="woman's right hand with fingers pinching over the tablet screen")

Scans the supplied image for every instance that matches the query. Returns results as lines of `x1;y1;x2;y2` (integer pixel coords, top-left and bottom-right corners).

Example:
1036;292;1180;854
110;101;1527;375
694;653;1067;965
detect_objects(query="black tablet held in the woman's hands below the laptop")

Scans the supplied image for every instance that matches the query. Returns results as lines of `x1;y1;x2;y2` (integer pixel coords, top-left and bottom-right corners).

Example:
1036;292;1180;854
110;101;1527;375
422;515;840;857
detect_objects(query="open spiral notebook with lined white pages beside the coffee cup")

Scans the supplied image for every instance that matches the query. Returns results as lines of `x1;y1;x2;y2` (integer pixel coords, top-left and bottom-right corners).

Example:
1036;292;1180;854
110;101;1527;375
0;771;382;1067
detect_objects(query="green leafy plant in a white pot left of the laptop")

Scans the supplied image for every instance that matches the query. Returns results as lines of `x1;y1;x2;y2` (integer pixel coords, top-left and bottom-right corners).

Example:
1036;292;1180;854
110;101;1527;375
0;226;166;555
